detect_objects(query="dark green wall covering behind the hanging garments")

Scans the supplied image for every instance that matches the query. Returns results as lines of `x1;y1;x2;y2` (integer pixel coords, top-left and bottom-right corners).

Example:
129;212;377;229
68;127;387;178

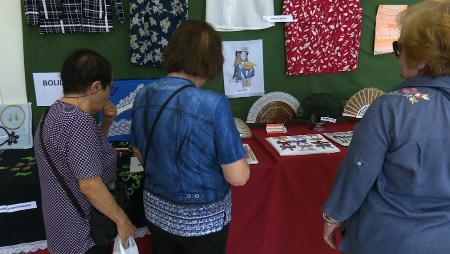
22;0;420;127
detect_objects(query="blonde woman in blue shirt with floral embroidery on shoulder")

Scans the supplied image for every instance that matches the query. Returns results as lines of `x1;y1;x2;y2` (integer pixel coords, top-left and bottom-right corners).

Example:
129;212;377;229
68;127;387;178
323;0;450;254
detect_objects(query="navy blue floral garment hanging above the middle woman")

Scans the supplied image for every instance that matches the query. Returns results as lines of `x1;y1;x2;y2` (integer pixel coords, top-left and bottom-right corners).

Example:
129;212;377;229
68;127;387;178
130;0;188;67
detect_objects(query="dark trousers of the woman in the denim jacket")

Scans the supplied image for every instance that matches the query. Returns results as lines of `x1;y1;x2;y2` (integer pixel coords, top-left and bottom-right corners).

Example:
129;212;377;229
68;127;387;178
149;223;228;254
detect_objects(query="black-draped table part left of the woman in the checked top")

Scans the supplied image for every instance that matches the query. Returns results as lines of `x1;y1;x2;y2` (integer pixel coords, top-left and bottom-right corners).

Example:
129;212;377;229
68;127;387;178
0;149;45;253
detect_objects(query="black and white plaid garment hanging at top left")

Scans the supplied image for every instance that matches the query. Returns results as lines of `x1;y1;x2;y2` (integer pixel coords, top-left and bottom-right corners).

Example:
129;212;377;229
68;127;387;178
23;0;125;34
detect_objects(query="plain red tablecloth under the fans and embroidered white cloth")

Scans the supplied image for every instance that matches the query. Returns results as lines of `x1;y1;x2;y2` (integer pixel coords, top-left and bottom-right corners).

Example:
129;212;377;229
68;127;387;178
227;123;353;254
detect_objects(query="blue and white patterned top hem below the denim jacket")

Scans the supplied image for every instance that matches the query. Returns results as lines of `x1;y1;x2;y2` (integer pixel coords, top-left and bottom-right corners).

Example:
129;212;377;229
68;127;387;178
144;191;231;237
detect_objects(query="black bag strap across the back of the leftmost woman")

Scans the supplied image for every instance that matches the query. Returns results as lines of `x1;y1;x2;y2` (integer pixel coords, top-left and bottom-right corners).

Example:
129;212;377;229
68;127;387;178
39;108;87;220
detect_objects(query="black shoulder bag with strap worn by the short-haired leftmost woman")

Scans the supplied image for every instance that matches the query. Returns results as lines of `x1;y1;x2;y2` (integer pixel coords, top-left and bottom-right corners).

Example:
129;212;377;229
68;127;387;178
39;110;131;246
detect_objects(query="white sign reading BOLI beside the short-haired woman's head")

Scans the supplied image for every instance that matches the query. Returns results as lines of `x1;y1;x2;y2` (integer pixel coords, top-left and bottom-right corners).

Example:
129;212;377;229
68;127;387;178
33;72;63;106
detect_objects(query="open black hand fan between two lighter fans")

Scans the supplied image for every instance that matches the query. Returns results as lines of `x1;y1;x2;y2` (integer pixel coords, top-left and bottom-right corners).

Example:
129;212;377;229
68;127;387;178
297;93;342;131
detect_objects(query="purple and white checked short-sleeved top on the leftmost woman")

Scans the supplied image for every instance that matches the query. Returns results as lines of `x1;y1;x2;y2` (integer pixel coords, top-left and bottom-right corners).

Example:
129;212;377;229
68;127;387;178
34;101;117;254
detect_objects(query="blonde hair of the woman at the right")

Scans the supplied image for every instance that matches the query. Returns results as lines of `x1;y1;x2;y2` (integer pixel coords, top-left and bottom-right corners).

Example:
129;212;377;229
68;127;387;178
399;0;450;77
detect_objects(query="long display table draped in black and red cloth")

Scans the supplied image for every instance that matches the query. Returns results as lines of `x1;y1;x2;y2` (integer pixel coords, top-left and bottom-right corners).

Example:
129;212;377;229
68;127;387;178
0;123;353;254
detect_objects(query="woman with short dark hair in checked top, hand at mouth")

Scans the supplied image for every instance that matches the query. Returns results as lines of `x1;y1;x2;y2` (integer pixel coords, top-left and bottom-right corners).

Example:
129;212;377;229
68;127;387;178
34;49;135;254
